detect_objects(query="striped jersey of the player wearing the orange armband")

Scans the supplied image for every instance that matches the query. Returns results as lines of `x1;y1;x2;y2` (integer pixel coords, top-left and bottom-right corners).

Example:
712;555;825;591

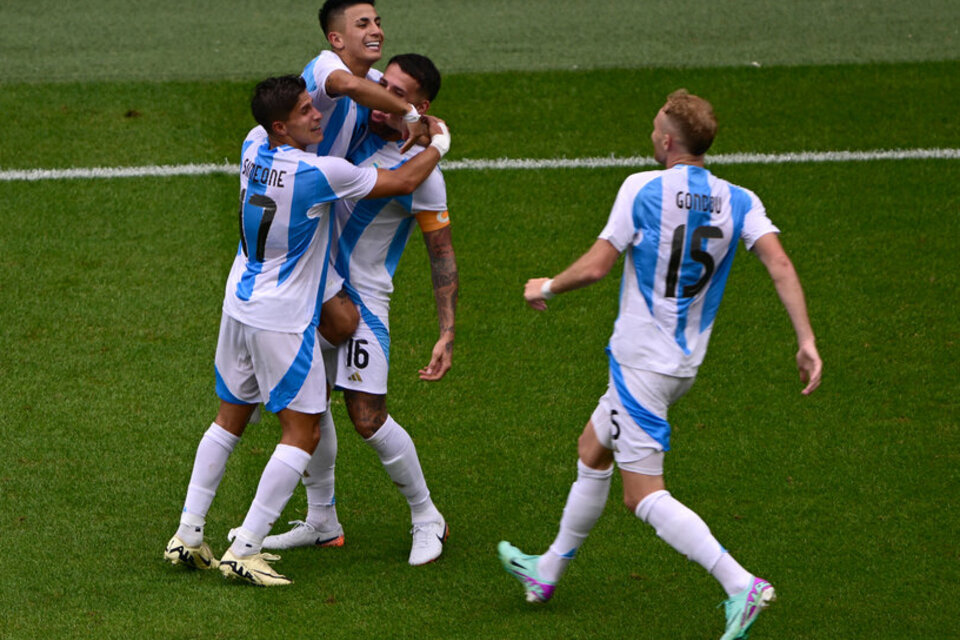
334;134;447;325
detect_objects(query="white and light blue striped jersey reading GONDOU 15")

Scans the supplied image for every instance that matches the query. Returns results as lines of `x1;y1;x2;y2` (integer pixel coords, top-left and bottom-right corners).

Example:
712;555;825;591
599;165;778;377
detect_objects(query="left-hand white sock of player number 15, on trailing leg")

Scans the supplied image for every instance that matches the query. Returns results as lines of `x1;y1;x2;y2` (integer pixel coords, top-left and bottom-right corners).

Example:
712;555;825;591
537;460;613;582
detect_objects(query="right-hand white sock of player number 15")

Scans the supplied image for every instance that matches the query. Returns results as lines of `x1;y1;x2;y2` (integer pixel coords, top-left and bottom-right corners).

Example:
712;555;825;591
636;490;753;595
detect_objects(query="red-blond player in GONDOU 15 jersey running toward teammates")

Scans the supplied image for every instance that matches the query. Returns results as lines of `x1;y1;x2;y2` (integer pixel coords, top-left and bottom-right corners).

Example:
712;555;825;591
498;89;823;640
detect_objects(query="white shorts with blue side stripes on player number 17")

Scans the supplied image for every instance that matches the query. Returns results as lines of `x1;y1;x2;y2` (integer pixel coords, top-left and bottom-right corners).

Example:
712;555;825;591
216;314;327;413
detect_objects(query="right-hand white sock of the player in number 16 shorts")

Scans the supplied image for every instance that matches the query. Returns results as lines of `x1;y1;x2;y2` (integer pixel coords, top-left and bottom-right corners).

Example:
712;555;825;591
365;416;442;523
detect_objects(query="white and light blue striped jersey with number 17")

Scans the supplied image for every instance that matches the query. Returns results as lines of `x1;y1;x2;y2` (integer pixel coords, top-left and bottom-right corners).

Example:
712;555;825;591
223;126;377;333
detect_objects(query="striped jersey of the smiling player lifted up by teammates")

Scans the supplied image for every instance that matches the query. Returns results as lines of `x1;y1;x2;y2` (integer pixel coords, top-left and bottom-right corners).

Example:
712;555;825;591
300;51;383;158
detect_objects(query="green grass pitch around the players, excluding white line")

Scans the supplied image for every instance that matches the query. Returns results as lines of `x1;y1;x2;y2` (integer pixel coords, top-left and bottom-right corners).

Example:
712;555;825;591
0;0;960;639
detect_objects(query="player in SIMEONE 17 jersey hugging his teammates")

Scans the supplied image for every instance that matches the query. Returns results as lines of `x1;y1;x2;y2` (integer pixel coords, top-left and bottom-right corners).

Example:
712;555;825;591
164;76;450;586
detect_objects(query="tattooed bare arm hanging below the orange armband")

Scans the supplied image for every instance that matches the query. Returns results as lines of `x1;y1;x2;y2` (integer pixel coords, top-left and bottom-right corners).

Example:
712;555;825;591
419;224;460;381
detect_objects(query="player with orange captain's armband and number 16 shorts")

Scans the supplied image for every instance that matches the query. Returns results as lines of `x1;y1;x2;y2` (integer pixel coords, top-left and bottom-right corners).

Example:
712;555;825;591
264;54;458;565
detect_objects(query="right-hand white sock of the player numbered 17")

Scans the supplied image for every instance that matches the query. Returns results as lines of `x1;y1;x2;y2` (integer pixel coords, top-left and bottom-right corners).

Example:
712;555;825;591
230;444;310;556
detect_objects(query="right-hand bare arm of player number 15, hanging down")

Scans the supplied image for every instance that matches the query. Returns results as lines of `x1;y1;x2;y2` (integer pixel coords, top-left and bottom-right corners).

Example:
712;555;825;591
752;233;823;395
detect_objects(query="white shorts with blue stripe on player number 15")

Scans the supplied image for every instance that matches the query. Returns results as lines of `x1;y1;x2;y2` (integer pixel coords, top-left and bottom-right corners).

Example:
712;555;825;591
590;358;695;476
